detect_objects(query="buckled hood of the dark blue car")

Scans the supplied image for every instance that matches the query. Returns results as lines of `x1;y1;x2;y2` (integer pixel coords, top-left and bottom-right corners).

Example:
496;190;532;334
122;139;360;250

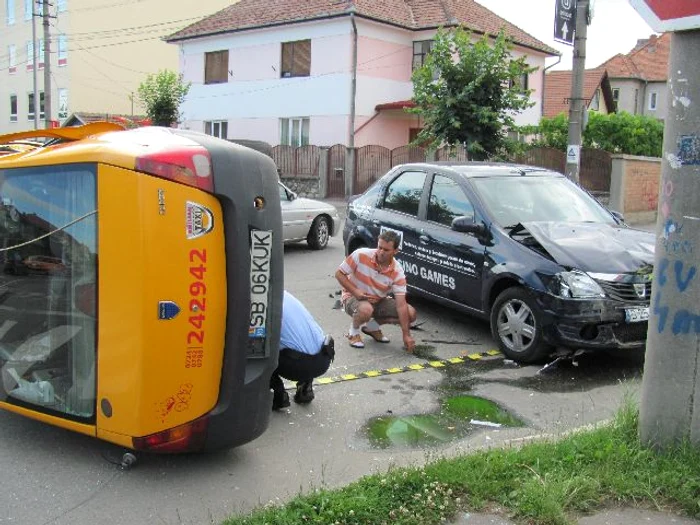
522;222;655;273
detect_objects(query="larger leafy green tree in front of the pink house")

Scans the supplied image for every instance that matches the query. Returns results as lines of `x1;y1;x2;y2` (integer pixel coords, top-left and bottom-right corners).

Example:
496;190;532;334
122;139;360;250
409;27;536;159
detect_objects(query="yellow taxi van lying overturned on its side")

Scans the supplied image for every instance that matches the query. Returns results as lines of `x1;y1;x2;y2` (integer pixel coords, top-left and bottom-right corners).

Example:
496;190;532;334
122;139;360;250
0;123;283;453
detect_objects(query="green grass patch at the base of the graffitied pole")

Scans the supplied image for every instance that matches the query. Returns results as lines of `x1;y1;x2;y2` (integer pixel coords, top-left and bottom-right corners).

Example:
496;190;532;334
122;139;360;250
224;405;700;525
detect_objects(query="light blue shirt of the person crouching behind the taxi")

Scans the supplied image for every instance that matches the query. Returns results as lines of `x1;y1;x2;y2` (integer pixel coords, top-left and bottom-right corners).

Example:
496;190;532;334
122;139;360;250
280;290;324;355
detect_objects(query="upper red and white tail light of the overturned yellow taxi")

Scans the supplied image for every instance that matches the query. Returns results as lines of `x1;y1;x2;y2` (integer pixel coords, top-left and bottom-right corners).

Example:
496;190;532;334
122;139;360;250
134;146;214;193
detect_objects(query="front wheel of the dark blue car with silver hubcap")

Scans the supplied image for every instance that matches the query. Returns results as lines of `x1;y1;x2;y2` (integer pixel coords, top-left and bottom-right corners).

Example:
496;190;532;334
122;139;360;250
491;287;552;363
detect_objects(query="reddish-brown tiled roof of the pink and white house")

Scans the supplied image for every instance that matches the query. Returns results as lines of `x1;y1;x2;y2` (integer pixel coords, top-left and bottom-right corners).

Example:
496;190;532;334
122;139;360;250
166;0;559;56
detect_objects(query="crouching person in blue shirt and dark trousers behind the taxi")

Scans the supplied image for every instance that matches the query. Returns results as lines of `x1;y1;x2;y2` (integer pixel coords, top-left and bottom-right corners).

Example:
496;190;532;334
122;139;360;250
270;290;335;410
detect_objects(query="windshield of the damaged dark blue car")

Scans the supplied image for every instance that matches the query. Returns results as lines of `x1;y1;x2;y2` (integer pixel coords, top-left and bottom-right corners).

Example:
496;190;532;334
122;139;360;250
471;176;615;228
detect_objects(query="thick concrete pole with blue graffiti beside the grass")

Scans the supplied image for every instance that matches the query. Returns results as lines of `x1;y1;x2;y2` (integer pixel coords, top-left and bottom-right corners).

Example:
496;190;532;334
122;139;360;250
640;29;700;448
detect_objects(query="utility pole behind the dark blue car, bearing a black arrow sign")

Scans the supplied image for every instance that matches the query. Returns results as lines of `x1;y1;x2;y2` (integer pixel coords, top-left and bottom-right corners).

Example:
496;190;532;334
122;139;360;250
566;0;589;183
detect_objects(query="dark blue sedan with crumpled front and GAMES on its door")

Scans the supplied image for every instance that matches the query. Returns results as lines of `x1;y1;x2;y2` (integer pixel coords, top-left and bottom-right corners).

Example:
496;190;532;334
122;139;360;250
343;163;655;362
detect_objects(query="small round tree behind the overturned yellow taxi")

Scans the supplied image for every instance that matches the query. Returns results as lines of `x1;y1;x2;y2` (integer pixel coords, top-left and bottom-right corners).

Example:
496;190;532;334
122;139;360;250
138;69;191;127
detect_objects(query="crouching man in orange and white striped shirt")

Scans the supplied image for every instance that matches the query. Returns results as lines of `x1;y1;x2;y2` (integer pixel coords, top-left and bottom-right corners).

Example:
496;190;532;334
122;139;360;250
335;230;416;353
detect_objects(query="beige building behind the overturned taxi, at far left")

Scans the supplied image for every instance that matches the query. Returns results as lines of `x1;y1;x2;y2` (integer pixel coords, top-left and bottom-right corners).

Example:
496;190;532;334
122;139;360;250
0;0;232;134
